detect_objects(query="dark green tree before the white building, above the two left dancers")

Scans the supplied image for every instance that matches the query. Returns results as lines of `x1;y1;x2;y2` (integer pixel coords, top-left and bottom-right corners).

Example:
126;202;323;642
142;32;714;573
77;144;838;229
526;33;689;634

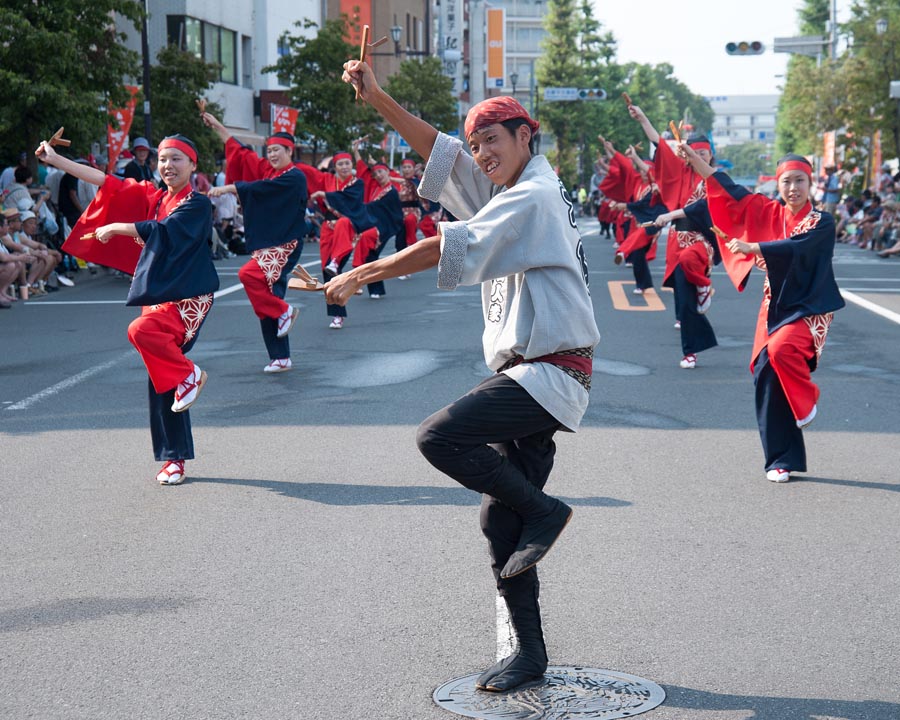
132;45;222;172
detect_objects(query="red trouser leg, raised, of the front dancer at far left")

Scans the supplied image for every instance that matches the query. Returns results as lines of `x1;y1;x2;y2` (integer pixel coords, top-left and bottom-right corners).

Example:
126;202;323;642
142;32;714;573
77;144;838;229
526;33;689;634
128;303;194;393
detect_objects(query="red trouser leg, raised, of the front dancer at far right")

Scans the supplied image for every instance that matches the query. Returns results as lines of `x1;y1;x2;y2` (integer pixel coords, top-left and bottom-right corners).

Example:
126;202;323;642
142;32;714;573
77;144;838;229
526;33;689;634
751;318;819;420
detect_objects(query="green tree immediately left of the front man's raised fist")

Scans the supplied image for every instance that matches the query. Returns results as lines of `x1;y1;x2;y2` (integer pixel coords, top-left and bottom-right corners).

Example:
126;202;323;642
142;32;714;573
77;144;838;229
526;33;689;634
263;17;381;158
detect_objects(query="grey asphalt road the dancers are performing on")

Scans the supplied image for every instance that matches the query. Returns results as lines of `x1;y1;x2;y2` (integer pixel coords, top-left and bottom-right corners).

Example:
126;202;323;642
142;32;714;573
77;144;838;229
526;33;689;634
0;221;900;720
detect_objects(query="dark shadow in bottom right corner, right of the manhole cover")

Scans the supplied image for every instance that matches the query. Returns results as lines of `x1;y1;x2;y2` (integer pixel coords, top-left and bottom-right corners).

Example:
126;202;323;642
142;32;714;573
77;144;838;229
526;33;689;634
661;685;900;720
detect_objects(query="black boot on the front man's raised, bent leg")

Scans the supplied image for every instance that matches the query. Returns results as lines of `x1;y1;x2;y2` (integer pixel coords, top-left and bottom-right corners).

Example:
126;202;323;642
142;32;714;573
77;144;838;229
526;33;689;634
487;471;572;580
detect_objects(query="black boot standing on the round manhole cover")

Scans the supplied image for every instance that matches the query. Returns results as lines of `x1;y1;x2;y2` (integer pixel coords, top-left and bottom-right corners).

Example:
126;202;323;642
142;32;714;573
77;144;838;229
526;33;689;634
475;584;547;692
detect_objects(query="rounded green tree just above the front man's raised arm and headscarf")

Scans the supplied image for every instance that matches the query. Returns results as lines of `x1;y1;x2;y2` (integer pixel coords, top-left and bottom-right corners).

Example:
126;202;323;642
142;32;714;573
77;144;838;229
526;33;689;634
385;57;459;132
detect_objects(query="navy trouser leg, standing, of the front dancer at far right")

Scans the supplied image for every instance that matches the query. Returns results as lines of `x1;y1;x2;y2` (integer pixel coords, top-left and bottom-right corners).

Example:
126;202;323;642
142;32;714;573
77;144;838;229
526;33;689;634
753;348;806;472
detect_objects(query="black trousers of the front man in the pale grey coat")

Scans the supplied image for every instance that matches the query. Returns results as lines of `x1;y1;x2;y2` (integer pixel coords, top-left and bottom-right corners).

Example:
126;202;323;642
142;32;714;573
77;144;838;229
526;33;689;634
417;373;560;596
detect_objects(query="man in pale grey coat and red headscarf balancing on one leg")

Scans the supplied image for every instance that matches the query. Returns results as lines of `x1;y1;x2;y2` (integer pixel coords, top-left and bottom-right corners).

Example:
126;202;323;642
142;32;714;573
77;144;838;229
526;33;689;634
326;60;600;692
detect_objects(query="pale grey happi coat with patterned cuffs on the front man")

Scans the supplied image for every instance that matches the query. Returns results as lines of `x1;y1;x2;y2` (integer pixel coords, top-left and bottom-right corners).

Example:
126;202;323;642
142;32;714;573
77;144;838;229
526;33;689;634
419;133;600;432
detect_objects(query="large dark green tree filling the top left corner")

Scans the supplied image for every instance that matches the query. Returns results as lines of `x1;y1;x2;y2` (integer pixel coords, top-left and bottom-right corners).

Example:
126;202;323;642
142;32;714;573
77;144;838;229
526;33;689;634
0;0;143;169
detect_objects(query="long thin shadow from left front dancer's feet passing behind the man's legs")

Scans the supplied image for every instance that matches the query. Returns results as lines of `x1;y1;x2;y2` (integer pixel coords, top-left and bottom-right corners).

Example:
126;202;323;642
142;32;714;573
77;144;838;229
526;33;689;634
186;477;631;507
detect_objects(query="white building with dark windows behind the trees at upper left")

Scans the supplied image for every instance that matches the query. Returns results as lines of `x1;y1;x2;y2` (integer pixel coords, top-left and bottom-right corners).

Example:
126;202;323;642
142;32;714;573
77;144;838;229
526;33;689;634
120;0;322;144
